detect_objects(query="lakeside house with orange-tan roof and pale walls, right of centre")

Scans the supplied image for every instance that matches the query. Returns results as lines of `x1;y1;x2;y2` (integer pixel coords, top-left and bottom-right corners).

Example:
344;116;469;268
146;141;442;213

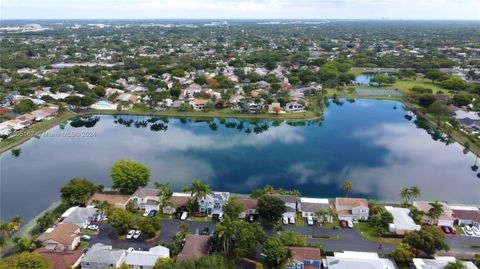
335;198;369;221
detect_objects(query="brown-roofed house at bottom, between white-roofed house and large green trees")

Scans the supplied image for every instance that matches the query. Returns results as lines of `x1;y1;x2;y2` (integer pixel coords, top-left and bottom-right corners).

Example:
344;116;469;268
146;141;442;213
177;234;210;261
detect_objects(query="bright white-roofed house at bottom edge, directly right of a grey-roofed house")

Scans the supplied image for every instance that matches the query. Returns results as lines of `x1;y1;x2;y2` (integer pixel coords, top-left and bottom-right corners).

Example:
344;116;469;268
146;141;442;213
125;246;170;269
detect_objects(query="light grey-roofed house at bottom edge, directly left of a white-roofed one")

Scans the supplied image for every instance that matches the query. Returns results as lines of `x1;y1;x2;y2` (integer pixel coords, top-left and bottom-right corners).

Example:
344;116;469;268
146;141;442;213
81;243;127;269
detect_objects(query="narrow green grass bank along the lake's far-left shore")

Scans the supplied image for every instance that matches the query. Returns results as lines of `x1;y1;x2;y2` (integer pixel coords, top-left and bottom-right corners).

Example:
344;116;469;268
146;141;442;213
0;111;76;153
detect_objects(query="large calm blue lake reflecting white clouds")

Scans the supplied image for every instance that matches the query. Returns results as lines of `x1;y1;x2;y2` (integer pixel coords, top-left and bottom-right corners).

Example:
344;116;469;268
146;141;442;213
0;100;480;219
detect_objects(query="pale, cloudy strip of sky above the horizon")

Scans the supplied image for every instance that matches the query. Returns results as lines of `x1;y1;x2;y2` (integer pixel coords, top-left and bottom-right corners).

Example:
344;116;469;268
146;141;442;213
0;0;480;20
